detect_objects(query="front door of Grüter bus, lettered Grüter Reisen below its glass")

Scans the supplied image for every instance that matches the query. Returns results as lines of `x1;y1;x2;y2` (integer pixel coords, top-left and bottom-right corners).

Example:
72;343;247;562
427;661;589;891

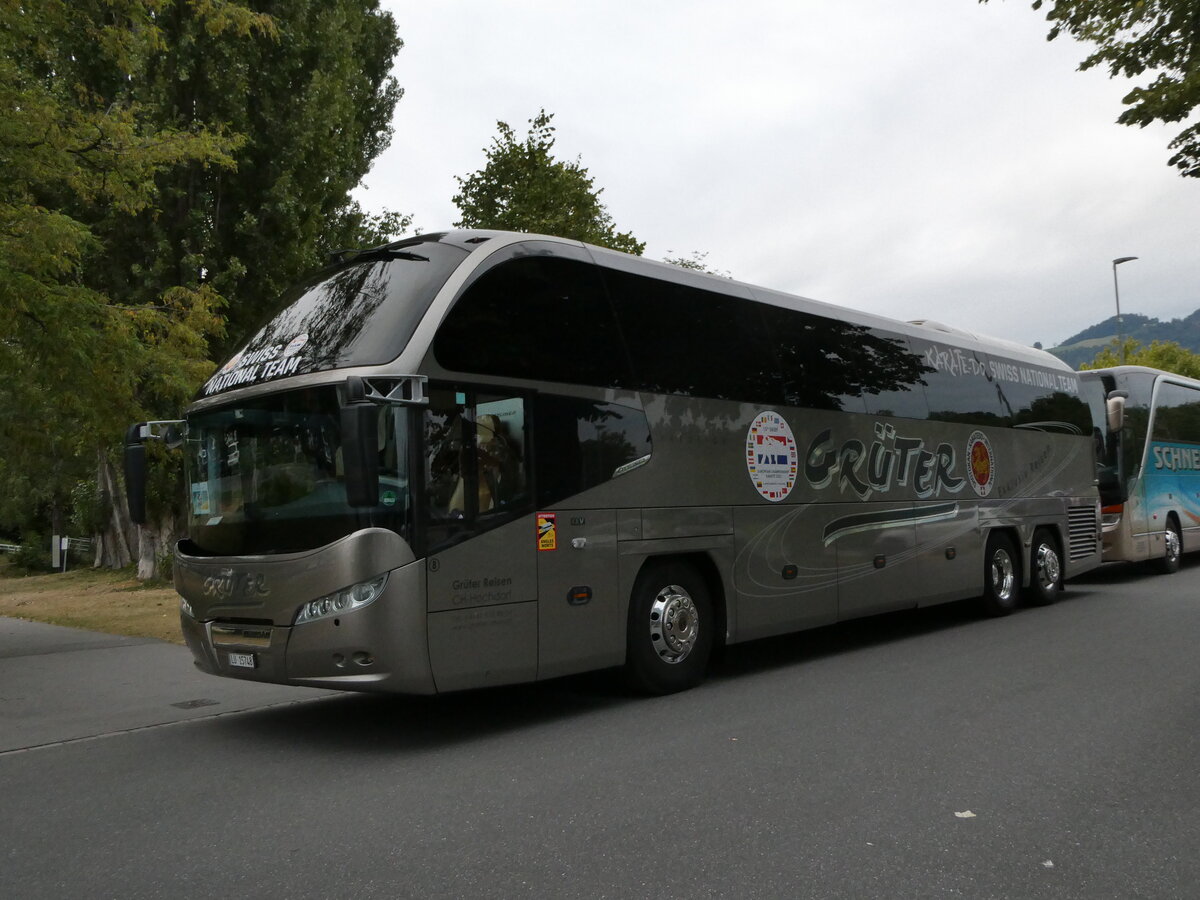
418;385;538;691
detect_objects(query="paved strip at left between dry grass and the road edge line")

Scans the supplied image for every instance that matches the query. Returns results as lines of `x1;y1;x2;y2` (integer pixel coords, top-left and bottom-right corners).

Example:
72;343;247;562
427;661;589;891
0;617;330;752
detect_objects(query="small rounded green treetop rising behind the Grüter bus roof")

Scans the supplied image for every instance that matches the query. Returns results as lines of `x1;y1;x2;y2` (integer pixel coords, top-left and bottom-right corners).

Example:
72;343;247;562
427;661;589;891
454;109;646;256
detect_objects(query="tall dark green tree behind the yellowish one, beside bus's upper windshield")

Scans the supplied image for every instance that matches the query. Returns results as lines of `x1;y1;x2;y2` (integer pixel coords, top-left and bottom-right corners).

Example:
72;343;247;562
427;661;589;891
90;0;410;359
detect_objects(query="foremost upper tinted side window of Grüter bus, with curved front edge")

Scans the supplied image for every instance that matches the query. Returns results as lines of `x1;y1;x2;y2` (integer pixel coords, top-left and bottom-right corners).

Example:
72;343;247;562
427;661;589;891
433;256;631;388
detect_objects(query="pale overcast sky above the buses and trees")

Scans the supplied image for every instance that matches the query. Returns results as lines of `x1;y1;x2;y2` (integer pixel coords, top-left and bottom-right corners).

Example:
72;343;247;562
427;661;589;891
358;0;1200;347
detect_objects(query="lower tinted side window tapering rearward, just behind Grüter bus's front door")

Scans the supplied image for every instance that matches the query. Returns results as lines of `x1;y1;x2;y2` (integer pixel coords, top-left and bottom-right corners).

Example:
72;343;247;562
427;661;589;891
534;395;650;506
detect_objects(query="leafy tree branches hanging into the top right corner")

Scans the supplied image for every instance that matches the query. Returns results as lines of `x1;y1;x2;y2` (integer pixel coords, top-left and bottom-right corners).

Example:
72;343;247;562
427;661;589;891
980;0;1200;178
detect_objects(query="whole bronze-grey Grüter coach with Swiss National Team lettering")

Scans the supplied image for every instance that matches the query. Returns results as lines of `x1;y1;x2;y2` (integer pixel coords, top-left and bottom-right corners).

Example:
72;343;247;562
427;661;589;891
127;232;1099;694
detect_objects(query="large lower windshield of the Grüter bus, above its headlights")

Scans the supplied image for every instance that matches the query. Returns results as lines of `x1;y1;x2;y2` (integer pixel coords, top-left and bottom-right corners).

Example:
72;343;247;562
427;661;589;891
186;385;410;556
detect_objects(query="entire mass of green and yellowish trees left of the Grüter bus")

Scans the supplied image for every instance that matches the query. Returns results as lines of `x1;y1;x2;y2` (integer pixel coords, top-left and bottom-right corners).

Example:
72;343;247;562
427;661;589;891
0;0;408;573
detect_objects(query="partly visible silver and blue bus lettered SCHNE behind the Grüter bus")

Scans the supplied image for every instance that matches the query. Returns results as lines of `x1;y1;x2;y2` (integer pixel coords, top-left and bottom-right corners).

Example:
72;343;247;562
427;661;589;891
1079;366;1200;574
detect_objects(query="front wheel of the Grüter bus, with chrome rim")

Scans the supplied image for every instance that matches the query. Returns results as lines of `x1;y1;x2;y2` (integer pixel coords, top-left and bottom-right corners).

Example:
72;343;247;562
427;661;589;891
625;560;716;694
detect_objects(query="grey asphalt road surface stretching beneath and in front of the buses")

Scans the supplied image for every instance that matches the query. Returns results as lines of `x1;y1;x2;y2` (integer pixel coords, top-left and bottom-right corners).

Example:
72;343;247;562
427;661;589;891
0;560;1200;900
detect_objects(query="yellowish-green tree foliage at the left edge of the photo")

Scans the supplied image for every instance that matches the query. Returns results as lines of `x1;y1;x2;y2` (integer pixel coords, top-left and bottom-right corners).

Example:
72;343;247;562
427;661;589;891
0;0;248;564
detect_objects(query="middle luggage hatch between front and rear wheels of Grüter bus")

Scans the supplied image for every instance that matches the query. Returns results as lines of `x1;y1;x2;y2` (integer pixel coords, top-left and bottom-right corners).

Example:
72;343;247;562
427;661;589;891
823;503;926;619
